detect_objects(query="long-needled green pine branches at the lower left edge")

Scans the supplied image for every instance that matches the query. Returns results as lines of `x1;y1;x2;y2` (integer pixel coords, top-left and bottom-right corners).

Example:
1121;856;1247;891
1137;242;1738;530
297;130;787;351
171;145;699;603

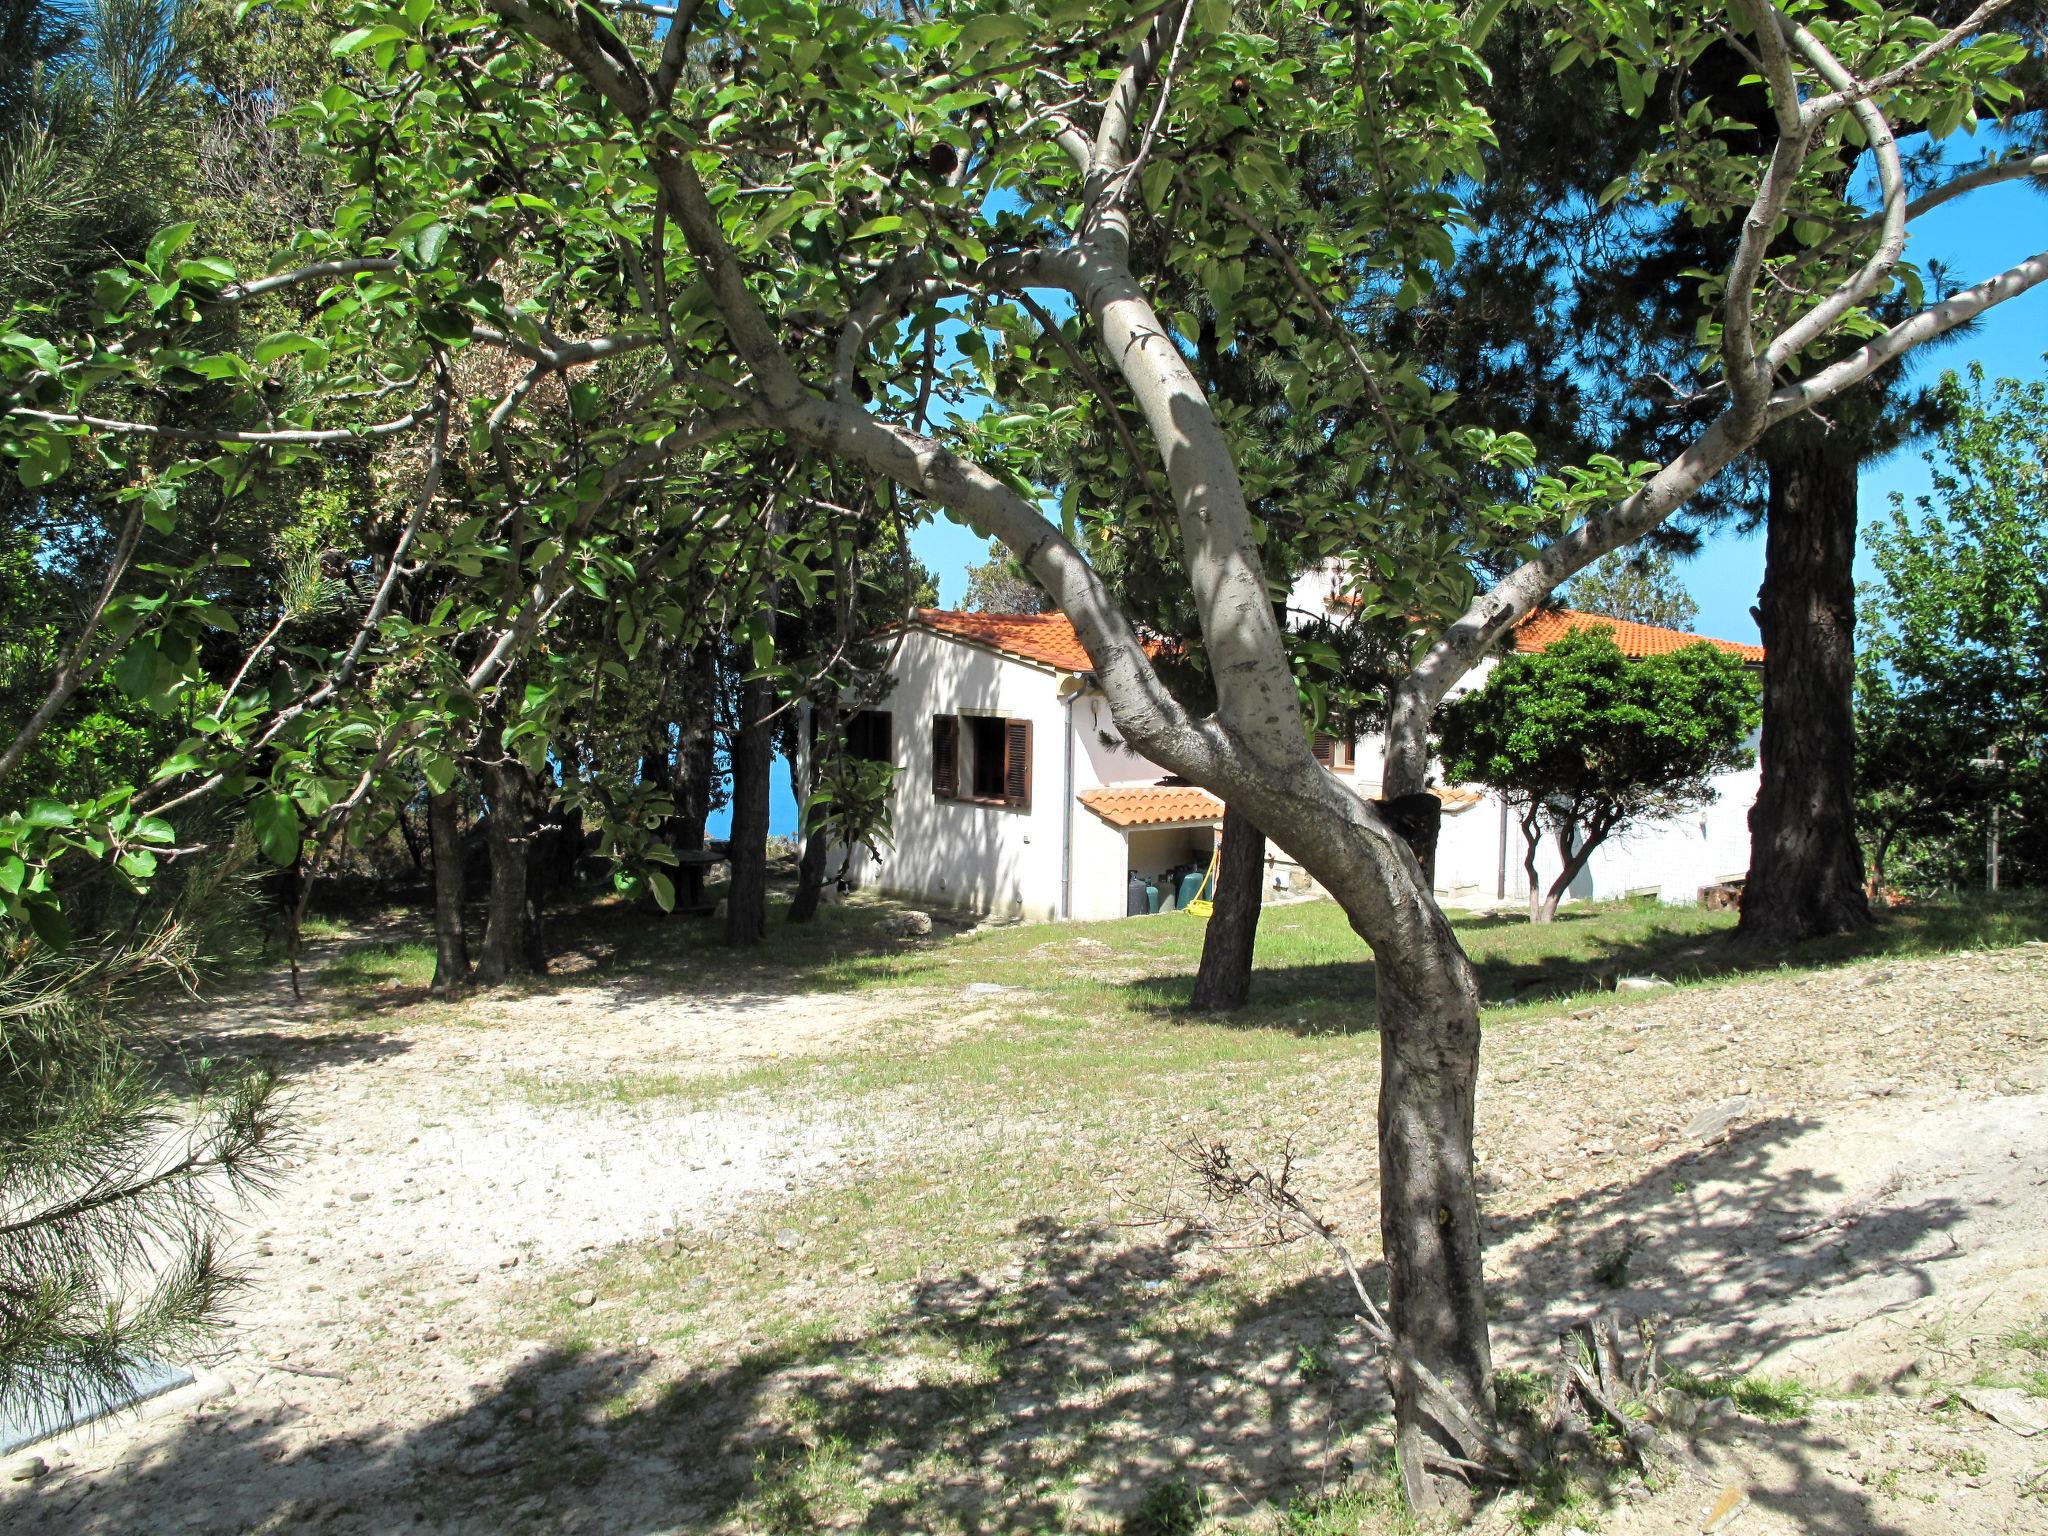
0;864;281;1413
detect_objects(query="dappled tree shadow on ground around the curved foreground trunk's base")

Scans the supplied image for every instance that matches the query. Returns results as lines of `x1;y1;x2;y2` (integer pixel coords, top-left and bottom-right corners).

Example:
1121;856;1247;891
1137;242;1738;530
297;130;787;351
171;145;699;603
19;1118;1964;1536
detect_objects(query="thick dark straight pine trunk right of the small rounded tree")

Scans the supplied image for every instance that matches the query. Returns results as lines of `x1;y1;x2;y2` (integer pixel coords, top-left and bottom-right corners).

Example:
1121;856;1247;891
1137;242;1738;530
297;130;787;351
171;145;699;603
1739;422;1870;944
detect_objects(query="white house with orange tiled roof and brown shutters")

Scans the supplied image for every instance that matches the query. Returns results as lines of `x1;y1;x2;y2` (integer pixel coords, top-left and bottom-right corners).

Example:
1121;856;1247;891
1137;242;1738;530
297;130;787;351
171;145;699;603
823;602;1763;920
